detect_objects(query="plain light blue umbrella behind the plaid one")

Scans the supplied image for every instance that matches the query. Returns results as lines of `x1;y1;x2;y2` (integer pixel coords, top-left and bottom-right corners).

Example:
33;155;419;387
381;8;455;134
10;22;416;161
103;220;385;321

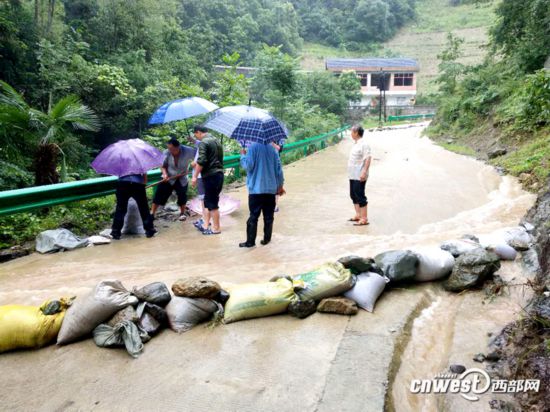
149;97;222;125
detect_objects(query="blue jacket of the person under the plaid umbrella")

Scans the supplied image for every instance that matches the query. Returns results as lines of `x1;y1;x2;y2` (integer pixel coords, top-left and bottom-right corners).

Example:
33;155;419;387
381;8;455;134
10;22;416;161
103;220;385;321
241;143;285;195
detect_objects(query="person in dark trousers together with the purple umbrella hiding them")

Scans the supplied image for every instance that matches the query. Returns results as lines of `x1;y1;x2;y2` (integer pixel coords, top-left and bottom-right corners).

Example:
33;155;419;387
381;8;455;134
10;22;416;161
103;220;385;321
92;139;163;239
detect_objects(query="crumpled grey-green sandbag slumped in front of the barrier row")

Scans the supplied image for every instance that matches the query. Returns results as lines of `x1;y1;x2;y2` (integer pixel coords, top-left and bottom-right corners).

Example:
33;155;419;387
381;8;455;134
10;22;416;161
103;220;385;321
94;320;149;358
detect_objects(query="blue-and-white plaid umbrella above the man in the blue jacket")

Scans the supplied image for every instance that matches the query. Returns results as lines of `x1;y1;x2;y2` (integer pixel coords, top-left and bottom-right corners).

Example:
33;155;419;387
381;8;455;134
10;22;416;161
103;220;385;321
205;106;289;147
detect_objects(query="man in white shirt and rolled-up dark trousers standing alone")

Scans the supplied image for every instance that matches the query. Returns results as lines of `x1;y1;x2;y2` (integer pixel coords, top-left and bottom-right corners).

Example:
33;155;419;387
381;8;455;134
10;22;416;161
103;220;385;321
348;125;371;226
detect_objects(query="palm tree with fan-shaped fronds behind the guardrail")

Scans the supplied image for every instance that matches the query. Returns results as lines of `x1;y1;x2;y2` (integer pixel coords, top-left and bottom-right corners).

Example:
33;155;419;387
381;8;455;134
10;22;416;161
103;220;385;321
0;81;100;185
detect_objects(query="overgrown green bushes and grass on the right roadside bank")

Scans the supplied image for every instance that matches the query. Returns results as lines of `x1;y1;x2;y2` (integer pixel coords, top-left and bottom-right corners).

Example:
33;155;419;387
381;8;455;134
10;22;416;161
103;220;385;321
429;0;550;187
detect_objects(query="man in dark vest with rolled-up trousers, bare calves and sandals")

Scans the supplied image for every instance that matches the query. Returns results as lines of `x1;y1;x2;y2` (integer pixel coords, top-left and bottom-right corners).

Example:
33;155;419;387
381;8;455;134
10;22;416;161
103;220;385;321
192;126;224;235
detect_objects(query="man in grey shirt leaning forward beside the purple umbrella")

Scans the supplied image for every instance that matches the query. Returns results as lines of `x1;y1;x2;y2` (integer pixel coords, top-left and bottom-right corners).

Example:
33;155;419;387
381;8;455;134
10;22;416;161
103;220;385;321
151;138;195;221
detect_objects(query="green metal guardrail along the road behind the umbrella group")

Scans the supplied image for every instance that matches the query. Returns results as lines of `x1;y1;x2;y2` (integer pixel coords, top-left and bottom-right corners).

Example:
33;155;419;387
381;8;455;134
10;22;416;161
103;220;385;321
0;125;349;216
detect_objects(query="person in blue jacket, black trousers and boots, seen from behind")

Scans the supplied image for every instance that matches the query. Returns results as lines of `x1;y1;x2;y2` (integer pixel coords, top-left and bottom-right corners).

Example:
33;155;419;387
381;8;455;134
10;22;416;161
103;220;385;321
239;143;285;248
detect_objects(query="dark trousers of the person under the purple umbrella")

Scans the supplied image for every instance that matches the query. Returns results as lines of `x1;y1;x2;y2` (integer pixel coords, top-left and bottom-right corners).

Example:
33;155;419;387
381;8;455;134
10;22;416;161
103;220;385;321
112;182;155;235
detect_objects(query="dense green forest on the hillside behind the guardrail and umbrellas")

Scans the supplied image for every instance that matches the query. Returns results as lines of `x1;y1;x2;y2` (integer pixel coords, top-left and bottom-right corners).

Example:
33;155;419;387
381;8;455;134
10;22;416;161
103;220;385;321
0;0;414;190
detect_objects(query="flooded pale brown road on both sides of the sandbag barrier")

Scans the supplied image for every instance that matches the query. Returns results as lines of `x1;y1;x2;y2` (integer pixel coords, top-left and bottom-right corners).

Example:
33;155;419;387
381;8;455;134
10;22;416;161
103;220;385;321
0;127;534;411
